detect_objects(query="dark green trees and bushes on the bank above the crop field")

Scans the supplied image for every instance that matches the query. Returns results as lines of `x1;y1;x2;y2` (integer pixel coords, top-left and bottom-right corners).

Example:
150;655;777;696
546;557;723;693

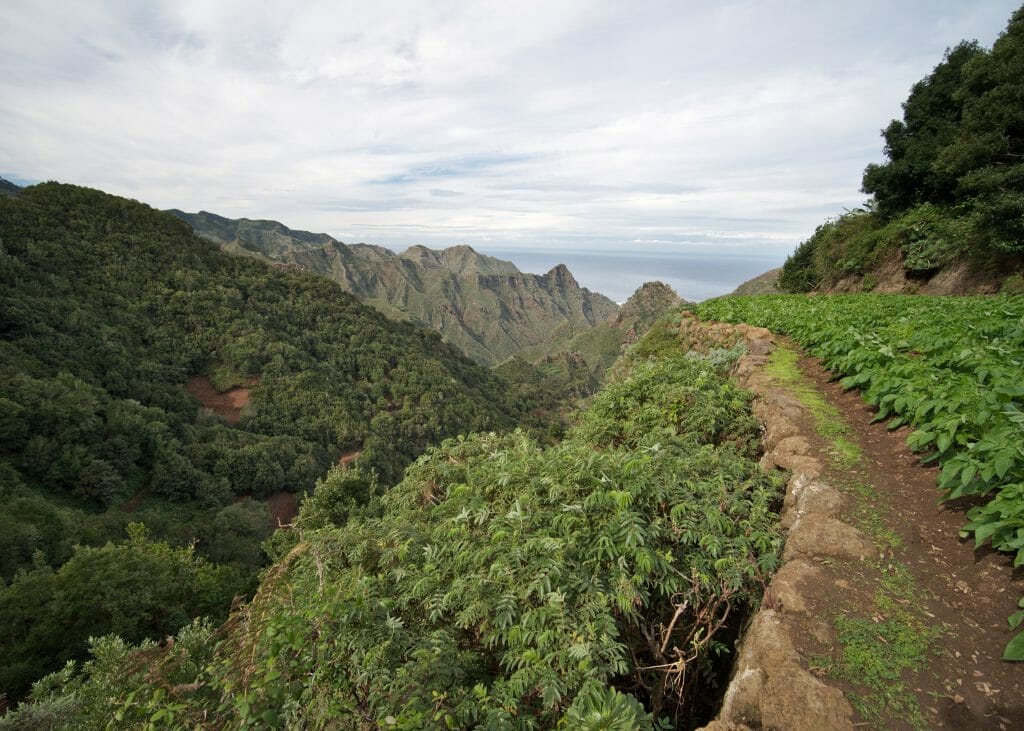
779;8;1024;292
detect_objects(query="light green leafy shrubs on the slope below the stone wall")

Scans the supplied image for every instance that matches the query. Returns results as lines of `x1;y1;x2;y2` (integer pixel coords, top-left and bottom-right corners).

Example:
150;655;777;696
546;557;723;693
8;305;780;729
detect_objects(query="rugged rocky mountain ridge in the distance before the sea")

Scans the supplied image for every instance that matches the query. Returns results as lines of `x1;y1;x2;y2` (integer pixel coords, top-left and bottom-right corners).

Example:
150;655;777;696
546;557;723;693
171;211;617;366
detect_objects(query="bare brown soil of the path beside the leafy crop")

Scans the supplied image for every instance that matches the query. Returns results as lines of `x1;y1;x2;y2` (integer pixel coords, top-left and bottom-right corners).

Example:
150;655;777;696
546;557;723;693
800;346;1024;730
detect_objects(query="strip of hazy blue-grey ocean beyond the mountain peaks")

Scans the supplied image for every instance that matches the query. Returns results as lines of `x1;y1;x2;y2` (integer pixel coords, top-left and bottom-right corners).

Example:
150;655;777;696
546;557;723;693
474;246;788;303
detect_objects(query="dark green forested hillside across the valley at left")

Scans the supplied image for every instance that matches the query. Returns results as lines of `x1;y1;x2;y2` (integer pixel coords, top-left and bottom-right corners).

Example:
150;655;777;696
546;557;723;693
0;183;521;698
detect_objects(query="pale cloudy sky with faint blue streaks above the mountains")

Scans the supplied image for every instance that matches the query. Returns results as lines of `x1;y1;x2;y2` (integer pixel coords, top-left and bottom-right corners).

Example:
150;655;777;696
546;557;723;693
0;0;1017;257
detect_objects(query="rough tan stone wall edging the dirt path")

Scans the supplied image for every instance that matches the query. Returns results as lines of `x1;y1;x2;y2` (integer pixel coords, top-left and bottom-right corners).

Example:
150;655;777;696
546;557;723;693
681;317;874;731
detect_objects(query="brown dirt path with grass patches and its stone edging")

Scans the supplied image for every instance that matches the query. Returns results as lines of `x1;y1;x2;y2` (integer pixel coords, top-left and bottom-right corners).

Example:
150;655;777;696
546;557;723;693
680;316;1024;731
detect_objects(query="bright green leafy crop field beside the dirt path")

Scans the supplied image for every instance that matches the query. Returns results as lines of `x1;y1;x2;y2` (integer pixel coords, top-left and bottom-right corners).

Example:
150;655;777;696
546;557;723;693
697;295;1024;660
